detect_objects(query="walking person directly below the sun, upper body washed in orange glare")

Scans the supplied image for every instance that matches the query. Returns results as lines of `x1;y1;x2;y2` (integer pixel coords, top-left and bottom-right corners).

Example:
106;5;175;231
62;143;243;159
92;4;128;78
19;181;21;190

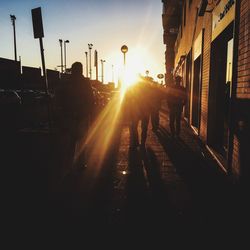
125;78;154;149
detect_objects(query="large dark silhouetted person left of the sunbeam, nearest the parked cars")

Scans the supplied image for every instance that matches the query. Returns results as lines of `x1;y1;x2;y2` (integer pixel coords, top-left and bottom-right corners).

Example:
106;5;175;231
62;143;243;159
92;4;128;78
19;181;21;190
57;62;94;170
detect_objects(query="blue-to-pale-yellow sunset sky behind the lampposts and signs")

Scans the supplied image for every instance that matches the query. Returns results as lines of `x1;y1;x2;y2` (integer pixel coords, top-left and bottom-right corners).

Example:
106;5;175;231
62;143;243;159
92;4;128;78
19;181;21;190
0;0;165;83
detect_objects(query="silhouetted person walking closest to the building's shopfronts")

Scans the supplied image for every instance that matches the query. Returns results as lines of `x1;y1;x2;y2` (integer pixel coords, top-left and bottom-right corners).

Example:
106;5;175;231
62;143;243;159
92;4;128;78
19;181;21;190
167;76;186;137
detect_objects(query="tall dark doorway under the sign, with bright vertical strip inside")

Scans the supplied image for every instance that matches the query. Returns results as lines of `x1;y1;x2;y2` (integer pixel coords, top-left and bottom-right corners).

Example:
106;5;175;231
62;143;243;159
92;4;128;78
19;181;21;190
208;22;233;159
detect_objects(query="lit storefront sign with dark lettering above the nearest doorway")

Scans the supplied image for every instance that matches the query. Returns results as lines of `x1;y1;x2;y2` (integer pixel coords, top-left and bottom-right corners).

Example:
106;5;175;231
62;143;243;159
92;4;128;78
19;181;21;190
212;0;236;40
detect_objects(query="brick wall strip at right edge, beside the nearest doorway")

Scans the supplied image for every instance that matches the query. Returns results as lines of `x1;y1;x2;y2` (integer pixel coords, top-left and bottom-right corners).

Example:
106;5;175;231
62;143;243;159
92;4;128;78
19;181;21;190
232;0;250;181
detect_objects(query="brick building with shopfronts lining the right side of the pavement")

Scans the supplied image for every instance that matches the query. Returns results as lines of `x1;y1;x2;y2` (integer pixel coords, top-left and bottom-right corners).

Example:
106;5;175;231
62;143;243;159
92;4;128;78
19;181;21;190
162;0;250;184
